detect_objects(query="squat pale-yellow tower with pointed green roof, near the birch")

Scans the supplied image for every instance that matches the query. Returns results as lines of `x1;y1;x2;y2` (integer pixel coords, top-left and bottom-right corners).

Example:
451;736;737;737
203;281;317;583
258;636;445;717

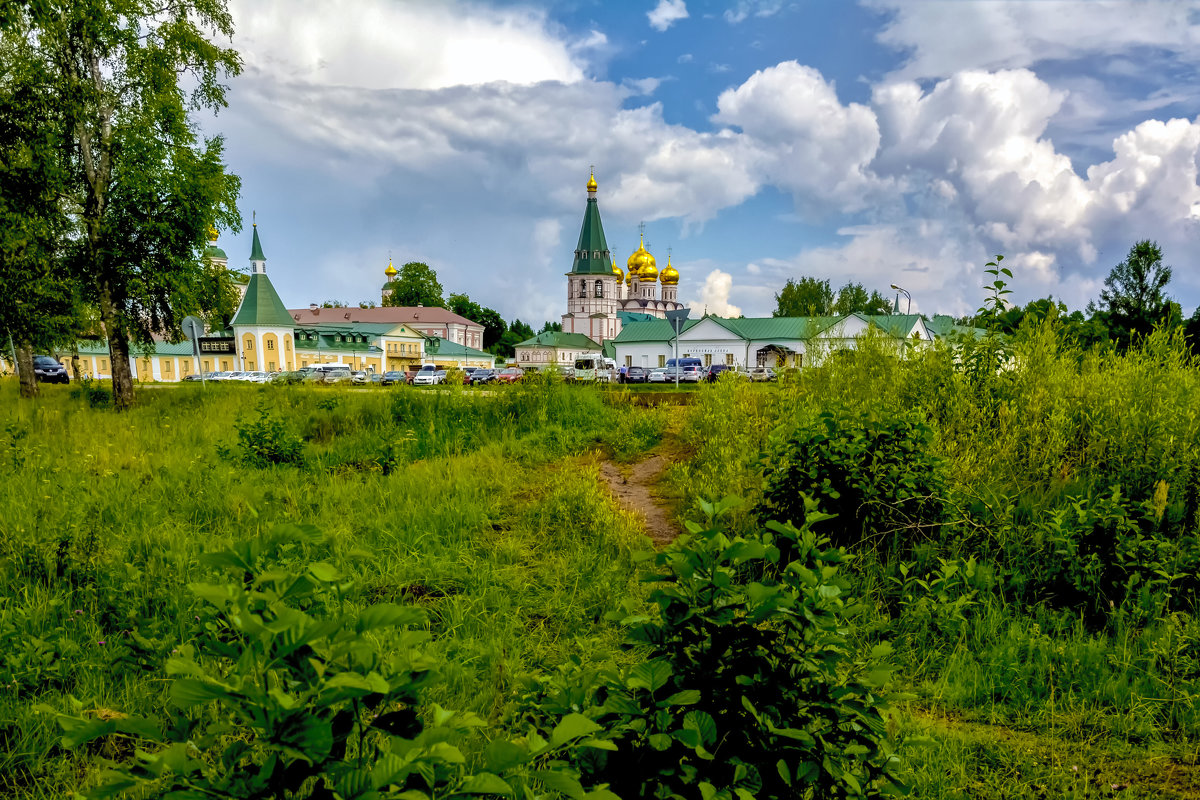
230;223;295;372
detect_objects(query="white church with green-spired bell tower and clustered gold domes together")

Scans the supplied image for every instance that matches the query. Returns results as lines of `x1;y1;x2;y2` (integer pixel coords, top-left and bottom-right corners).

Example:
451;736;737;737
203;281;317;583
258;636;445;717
563;173;683;344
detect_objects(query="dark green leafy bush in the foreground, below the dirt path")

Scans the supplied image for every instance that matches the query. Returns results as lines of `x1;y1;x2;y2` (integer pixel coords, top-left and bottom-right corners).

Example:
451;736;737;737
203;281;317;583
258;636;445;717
527;500;899;798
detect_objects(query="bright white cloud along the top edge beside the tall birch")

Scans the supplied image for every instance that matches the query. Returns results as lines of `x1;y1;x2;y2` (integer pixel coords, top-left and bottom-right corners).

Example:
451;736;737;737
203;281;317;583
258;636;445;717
232;0;585;89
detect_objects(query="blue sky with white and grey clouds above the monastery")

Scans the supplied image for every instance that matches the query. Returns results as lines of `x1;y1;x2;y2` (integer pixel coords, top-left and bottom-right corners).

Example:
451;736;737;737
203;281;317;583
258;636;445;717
200;0;1200;330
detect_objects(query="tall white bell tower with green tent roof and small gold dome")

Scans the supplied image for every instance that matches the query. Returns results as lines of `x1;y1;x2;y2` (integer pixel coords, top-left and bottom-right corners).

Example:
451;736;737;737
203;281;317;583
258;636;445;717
563;172;624;342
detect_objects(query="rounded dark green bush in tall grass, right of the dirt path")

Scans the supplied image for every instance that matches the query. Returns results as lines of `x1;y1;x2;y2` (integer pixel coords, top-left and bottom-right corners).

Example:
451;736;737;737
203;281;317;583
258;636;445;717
758;409;944;551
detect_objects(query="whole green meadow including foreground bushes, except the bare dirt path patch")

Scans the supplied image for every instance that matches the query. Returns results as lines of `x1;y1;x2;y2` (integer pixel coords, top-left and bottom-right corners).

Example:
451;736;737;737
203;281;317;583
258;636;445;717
0;324;1200;800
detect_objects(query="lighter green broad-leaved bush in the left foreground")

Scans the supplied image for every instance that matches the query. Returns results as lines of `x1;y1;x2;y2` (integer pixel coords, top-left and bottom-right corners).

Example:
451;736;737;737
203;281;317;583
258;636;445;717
42;528;612;800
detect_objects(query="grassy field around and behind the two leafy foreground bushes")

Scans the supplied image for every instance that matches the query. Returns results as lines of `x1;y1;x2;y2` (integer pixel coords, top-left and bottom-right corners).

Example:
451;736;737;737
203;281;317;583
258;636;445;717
0;331;1200;798
